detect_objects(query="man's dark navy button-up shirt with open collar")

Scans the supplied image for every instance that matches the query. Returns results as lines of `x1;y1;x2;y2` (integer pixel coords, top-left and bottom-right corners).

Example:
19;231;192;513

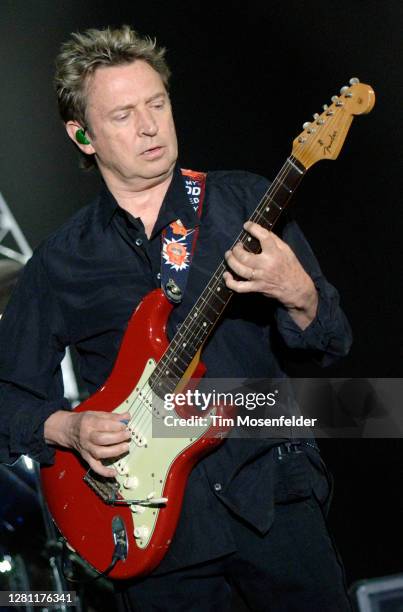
0;167;351;569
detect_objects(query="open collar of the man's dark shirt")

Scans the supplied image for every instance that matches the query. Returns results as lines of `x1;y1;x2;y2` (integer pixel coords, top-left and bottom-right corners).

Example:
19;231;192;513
100;163;200;237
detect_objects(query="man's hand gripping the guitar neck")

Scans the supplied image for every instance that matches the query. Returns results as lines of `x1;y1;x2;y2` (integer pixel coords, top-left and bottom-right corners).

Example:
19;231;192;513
224;221;318;329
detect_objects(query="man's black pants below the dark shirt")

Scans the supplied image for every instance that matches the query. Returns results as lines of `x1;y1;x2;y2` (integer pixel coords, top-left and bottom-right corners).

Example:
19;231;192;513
117;496;351;612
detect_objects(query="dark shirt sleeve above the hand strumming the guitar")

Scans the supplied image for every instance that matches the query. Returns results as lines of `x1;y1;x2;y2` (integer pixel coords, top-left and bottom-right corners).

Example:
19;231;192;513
0;251;71;464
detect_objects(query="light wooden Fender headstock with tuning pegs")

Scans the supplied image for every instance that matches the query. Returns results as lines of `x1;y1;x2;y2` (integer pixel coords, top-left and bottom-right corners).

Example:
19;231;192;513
292;78;375;169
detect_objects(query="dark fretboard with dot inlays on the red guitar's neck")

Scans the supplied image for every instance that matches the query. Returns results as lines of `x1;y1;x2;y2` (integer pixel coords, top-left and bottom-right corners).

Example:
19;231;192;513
149;156;306;394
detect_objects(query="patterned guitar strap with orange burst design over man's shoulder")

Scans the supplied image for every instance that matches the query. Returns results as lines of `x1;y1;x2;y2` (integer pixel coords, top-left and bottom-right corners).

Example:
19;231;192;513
161;169;207;304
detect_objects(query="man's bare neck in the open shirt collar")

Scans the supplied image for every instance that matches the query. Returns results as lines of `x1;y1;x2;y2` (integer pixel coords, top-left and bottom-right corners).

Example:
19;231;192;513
104;171;173;238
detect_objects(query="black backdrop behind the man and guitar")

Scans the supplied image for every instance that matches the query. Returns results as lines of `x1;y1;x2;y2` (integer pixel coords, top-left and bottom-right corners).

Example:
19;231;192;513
0;0;403;596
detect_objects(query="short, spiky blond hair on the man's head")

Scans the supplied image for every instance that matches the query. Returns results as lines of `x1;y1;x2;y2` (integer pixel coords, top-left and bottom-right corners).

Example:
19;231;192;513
54;25;171;168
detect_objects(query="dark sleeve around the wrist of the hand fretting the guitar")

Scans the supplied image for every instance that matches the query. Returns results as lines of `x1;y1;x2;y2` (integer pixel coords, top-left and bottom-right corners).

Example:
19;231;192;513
275;221;352;366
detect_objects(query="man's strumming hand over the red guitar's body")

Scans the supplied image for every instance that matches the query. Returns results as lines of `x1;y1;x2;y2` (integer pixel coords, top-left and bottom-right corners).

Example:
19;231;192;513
44;410;131;478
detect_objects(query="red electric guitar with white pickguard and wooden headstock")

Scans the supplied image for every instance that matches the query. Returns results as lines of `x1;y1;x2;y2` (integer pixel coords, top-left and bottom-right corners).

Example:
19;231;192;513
41;79;375;579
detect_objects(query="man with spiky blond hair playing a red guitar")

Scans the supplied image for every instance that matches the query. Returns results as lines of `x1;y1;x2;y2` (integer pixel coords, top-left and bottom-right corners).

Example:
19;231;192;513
0;26;350;612
